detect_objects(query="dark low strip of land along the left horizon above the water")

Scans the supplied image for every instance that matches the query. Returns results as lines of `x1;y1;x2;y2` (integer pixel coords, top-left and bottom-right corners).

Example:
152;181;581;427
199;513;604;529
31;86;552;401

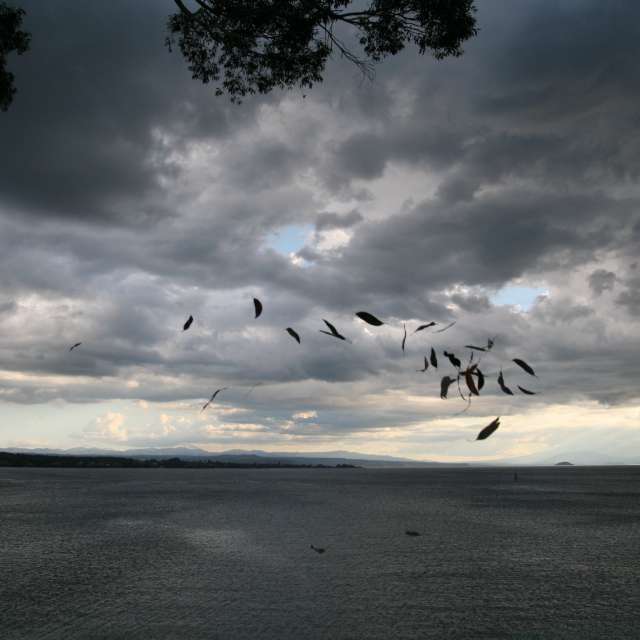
0;451;357;469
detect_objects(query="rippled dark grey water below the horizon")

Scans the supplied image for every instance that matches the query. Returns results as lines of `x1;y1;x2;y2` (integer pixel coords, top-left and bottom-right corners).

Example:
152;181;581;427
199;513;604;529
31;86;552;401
0;467;640;640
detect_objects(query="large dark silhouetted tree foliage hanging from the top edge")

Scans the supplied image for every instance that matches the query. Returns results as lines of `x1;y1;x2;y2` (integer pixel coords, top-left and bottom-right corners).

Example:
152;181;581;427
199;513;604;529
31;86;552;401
167;0;477;102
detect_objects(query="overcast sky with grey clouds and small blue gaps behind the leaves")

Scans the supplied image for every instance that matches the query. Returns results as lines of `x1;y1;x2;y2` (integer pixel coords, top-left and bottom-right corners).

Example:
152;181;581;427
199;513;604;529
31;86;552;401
0;0;640;461
